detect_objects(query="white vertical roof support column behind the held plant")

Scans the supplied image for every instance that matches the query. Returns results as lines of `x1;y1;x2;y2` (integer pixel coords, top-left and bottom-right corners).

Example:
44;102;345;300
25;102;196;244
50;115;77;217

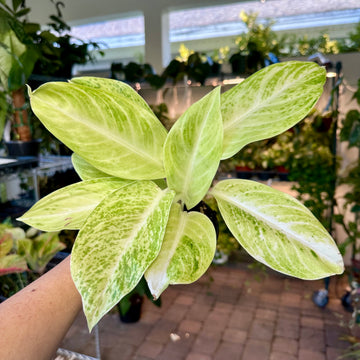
144;5;171;74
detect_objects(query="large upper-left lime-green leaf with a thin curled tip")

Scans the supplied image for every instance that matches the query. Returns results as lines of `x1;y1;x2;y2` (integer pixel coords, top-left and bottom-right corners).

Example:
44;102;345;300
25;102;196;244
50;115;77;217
29;82;167;180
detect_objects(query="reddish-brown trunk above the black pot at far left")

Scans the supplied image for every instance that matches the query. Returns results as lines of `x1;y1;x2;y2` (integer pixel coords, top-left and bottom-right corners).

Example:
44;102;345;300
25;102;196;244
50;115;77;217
12;88;31;141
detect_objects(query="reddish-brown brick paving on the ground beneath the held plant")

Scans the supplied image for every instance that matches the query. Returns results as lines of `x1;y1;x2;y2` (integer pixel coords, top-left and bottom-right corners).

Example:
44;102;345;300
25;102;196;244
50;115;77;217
61;264;358;360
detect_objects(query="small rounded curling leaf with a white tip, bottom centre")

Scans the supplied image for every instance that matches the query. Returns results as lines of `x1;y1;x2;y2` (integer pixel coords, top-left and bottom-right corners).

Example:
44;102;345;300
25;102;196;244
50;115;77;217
145;203;216;299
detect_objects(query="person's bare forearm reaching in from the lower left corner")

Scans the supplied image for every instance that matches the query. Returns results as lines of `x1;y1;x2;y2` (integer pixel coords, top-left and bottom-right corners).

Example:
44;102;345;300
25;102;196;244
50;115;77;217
0;256;81;360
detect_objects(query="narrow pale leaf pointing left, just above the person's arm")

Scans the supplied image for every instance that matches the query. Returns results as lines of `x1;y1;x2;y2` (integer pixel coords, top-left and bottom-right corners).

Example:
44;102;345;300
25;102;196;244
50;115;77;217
18;177;134;231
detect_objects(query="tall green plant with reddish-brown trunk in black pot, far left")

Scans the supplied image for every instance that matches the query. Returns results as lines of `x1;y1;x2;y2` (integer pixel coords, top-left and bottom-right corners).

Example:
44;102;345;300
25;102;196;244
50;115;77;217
0;1;39;155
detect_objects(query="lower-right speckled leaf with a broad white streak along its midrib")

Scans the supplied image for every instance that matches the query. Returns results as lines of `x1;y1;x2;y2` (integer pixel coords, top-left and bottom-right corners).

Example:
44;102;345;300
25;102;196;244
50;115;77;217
212;180;344;280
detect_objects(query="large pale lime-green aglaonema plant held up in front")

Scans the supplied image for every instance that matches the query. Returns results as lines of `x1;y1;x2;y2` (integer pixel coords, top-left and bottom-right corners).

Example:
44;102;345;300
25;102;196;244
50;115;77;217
20;62;343;330
